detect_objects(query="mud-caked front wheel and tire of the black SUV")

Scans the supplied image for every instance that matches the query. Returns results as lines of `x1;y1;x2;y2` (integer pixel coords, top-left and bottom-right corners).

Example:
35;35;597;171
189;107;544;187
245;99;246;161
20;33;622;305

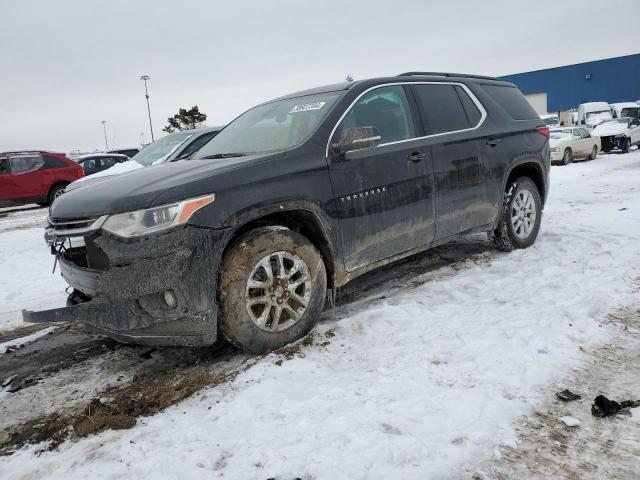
218;227;327;353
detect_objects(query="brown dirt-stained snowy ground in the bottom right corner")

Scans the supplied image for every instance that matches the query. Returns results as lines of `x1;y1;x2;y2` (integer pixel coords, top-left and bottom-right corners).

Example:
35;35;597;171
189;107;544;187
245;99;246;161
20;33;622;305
472;309;640;480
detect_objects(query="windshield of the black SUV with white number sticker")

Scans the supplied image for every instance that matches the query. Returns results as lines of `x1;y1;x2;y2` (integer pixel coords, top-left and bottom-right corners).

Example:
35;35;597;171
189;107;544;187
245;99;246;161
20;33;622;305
196;92;343;158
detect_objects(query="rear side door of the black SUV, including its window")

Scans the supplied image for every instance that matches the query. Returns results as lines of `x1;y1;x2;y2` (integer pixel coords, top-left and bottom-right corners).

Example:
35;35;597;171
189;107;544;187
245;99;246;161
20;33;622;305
412;83;495;239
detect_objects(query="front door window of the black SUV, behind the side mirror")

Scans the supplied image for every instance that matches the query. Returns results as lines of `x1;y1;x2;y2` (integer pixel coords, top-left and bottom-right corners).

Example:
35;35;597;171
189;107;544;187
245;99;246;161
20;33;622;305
332;85;416;143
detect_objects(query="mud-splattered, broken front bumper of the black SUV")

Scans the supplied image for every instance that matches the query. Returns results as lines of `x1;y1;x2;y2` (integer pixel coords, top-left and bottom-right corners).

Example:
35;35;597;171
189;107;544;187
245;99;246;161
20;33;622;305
23;225;227;346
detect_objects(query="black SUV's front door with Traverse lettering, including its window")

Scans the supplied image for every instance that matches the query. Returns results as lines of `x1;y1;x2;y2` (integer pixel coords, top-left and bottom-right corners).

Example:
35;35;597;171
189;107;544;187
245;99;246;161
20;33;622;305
328;85;434;271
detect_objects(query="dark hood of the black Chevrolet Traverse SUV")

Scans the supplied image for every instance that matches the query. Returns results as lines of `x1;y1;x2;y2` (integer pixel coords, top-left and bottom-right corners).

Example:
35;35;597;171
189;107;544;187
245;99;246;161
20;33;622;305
50;154;282;220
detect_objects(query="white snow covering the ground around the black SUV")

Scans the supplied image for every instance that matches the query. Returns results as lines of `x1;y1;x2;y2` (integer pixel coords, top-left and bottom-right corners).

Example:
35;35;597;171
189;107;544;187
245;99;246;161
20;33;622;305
0;151;640;479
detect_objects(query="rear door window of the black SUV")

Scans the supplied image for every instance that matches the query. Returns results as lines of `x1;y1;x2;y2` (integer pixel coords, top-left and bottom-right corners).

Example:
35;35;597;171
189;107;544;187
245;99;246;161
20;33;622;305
413;84;477;135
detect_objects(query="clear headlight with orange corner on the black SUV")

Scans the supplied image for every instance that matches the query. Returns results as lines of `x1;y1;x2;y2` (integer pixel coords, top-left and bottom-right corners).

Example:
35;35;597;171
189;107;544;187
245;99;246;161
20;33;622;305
102;194;215;238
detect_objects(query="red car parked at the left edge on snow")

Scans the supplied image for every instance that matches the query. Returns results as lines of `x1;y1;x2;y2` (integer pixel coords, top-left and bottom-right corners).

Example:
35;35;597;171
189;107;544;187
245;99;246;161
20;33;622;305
0;151;84;206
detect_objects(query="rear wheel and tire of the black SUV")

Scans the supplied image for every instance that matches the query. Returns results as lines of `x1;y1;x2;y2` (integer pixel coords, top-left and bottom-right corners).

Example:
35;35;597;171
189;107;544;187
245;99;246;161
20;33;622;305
490;177;542;252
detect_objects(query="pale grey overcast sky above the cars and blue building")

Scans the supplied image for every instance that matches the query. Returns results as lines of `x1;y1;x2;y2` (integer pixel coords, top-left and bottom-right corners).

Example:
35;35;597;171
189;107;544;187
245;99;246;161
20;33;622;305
0;0;640;151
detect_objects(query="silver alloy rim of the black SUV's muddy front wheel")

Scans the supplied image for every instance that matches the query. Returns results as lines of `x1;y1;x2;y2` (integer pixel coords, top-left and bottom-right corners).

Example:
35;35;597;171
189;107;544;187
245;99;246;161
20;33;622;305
245;251;311;332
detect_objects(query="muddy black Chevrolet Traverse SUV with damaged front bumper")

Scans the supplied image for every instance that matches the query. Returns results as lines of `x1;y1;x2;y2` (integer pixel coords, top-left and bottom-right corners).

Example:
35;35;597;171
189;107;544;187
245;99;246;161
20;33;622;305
23;72;550;352
